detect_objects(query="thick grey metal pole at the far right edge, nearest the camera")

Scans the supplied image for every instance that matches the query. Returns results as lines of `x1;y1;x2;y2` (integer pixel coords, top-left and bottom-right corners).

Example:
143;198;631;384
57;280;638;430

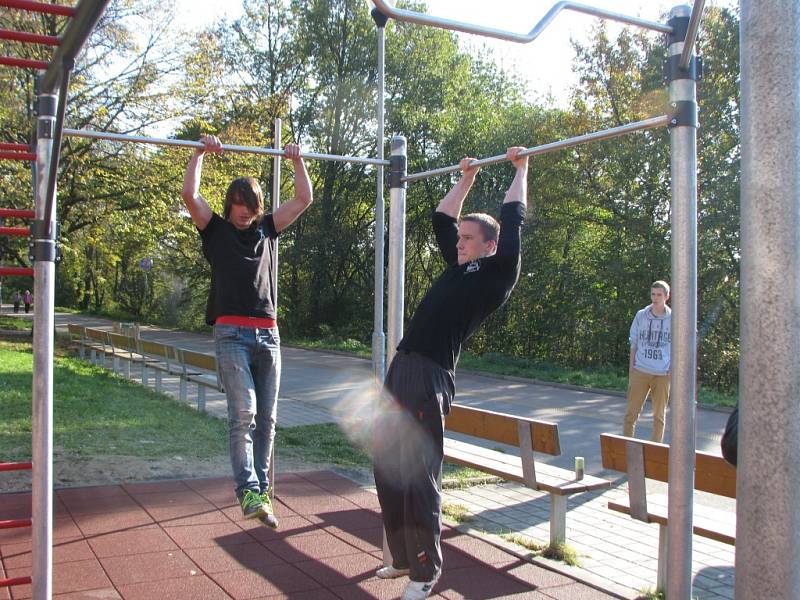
736;0;800;600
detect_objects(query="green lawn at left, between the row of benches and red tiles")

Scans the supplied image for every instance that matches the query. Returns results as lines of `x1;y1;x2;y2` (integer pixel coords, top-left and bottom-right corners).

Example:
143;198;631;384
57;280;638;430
0;340;227;460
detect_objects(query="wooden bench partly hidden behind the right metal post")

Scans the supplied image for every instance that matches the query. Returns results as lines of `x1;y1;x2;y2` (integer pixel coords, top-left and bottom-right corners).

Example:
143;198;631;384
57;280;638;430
600;433;736;591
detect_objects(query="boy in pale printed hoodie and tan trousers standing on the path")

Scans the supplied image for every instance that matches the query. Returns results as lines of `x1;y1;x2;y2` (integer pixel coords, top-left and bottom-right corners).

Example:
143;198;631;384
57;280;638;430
622;281;672;442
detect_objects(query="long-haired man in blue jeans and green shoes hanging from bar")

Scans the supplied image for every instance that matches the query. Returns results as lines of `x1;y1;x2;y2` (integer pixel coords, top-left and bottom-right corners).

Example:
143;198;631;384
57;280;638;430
181;135;313;527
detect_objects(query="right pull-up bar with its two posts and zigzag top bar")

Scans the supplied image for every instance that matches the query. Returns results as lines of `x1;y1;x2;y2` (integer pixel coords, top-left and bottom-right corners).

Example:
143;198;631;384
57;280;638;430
373;0;704;600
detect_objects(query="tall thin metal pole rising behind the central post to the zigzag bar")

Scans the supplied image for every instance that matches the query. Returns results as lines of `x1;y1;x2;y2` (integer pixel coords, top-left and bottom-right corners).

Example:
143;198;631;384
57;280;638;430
372;8;387;382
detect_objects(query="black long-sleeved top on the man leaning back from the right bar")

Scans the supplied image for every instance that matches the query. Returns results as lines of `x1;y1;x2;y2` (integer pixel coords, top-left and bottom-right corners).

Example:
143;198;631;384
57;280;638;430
397;202;525;371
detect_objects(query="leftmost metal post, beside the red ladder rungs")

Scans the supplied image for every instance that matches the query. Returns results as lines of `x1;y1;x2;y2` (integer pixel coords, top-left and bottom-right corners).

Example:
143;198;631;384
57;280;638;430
31;81;58;600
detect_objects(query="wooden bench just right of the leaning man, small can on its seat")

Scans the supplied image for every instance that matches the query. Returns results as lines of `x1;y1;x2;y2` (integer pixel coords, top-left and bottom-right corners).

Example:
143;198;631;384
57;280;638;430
444;404;611;544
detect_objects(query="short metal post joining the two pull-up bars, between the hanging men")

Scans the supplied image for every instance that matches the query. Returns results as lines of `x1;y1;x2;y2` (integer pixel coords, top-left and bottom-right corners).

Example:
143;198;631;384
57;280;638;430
386;135;406;365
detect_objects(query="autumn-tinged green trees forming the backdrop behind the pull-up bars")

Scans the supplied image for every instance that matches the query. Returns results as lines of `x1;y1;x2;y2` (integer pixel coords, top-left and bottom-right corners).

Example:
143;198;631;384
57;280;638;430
0;5;739;394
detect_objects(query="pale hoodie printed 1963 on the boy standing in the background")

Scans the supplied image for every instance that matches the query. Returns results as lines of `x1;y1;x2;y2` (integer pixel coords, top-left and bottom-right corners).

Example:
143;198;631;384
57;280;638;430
630;304;672;375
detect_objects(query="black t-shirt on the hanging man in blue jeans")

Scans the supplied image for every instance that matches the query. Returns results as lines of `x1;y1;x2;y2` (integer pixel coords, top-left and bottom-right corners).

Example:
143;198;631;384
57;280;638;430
200;213;278;325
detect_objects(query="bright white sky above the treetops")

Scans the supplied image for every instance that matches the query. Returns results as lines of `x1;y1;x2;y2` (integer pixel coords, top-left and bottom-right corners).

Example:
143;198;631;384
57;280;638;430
172;0;738;106
